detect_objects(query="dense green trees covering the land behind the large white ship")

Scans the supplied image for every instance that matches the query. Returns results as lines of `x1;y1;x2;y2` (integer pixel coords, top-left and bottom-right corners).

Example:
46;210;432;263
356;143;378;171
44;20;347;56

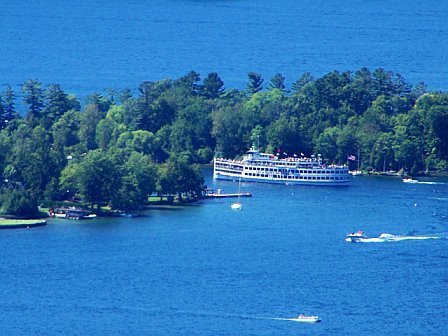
0;68;448;216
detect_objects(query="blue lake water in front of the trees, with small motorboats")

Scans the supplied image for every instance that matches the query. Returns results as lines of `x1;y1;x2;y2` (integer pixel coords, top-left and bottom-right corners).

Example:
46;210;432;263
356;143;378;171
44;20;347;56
0;170;448;336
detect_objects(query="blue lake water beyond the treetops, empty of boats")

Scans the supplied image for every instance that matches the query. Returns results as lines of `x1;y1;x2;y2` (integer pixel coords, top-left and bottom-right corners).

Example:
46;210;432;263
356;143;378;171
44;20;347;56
0;0;448;103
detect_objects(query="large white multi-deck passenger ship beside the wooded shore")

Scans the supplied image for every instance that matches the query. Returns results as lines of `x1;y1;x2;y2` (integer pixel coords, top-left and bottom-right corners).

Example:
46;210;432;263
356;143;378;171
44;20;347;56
213;148;350;186
